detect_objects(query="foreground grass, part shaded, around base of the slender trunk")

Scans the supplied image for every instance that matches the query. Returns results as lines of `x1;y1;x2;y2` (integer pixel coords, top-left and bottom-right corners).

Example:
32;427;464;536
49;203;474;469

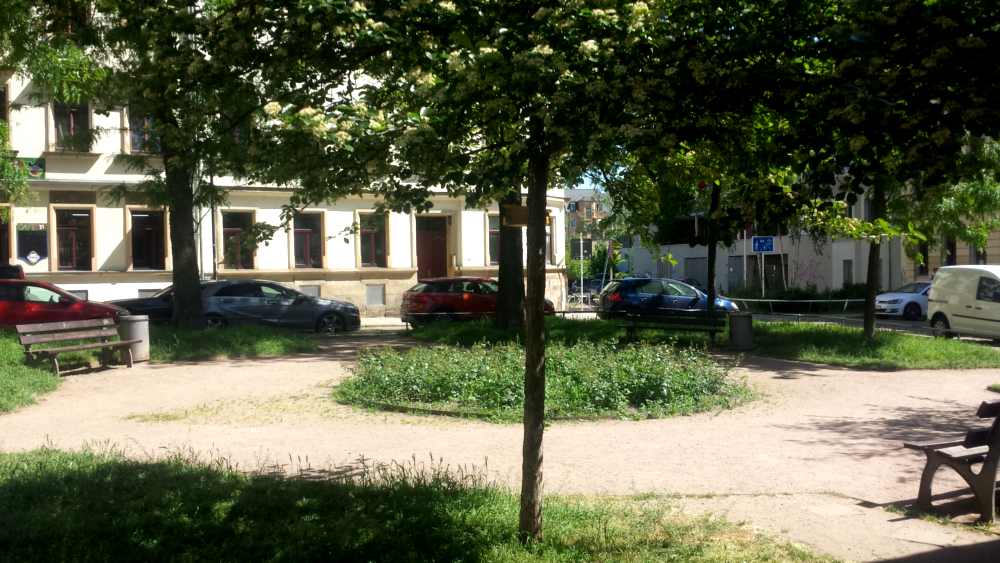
0;449;832;563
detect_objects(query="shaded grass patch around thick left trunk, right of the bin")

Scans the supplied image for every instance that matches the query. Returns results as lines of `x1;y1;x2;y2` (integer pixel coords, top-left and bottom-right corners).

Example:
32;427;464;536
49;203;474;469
149;324;318;363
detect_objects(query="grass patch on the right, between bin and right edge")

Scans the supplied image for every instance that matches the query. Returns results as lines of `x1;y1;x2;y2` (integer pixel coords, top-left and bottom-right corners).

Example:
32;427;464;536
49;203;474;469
753;322;1000;370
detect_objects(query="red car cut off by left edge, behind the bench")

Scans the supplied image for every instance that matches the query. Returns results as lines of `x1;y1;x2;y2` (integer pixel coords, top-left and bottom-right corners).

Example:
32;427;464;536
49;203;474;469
0;279;128;326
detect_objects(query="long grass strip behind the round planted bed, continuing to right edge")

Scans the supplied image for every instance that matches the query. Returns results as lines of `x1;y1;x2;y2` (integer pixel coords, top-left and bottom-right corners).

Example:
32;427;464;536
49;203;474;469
409;317;1000;370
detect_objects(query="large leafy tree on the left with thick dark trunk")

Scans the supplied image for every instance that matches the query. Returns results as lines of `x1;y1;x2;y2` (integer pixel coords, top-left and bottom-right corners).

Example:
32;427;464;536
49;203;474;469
0;0;388;327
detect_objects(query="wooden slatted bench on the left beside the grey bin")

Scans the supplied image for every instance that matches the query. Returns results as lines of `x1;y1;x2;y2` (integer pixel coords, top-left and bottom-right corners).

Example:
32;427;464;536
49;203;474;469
15;319;142;375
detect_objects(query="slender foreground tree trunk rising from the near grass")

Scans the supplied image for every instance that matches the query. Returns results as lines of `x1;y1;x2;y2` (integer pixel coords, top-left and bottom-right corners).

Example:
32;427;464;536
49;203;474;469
518;117;549;542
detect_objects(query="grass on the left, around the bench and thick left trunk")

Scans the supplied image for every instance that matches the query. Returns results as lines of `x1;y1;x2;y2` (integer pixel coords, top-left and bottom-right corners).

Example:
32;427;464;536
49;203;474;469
0;325;317;412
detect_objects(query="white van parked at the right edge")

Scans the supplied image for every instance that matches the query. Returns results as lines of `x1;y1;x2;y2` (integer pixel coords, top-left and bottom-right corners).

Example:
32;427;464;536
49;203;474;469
927;266;1000;340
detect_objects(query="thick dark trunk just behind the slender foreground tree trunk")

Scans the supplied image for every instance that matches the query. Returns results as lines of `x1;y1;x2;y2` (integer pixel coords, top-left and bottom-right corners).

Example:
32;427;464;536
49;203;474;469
494;186;524;329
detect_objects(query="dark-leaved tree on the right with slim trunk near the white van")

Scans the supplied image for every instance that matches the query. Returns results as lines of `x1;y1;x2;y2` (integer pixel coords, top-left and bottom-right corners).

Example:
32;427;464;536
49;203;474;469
788;0;1000;339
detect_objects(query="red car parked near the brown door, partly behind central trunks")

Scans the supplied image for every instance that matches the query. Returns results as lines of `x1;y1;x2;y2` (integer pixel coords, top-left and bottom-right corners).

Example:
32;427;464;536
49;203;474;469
399;278;556;324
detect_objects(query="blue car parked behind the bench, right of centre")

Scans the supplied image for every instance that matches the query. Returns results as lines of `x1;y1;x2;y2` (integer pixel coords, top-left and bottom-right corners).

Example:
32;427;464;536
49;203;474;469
597;278;740;319
